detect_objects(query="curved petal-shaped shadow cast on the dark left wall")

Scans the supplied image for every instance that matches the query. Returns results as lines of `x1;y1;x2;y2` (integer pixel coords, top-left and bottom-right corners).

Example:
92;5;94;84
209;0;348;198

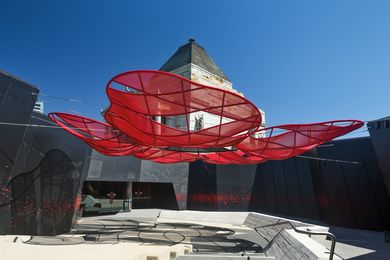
0;150;81;235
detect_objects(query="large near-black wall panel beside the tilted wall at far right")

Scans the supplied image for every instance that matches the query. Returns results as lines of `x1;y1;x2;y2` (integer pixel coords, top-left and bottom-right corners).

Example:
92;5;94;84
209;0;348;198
317;137;390;230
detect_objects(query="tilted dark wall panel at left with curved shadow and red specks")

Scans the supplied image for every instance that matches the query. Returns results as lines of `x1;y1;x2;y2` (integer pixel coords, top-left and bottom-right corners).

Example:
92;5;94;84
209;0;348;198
7;112;90;235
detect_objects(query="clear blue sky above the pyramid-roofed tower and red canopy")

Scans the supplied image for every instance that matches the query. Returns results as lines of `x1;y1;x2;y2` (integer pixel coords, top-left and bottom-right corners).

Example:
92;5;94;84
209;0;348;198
0;0;390;132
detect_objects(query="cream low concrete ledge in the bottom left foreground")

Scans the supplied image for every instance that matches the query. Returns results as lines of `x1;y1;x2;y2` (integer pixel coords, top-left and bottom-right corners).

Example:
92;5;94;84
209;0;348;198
0;236;192;260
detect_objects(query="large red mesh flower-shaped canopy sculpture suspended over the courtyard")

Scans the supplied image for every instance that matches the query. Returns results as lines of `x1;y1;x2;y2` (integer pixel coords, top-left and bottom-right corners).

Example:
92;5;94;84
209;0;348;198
49;71;363;164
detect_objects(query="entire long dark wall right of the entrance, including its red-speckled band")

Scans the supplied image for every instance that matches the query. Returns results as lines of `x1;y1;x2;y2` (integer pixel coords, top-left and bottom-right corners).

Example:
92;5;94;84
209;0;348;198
188;137;390;230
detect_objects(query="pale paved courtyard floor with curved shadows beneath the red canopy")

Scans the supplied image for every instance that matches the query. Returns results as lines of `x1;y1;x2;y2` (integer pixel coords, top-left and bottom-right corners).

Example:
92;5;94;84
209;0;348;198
0;209;390;259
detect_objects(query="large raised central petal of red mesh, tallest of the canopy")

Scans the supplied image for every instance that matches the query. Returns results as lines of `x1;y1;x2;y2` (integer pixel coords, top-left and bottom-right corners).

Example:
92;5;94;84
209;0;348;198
105;71;261;148
